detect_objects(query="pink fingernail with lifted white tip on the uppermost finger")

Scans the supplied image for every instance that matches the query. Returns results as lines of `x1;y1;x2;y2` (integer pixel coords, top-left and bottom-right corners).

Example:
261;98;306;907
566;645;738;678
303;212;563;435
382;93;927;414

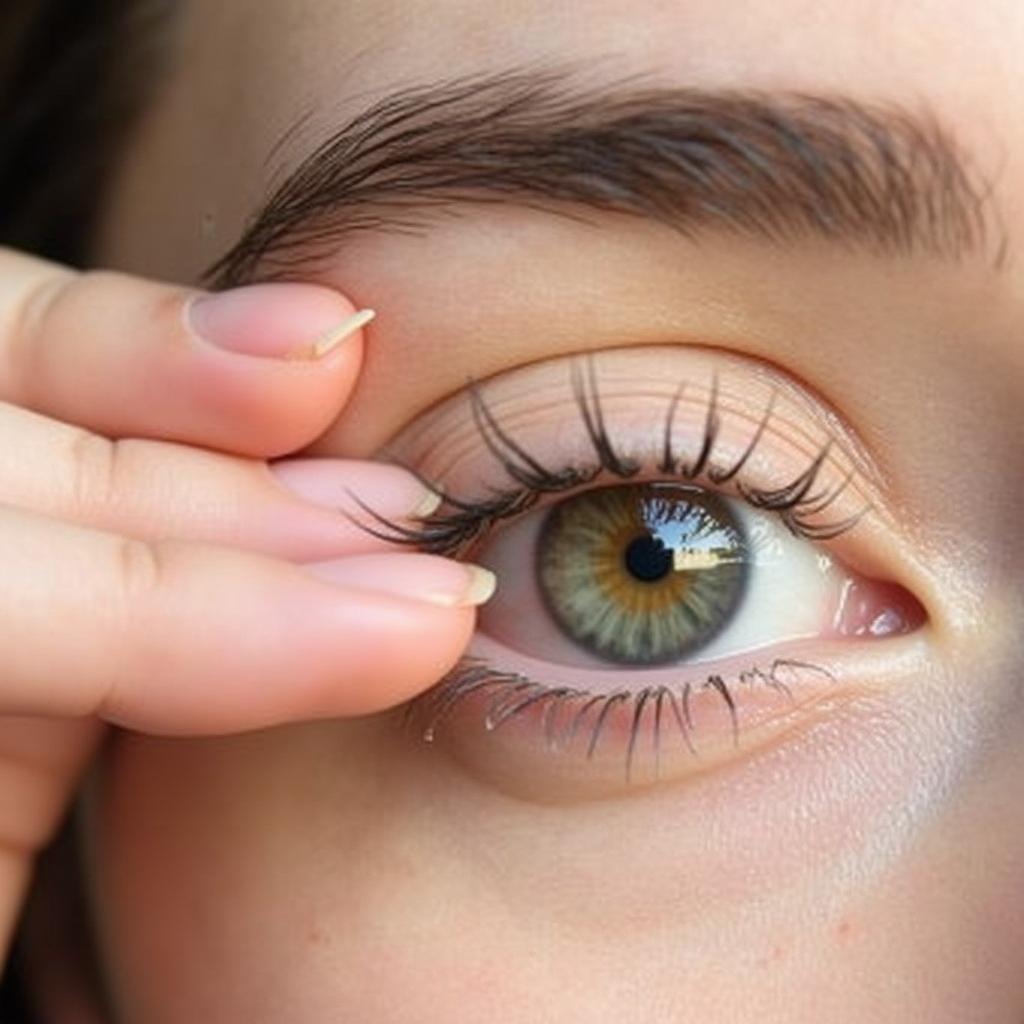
185;284;375;359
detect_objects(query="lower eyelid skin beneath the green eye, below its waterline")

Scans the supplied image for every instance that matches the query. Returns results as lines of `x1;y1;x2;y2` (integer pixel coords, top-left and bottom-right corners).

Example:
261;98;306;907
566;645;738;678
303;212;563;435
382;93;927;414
406;634;928;803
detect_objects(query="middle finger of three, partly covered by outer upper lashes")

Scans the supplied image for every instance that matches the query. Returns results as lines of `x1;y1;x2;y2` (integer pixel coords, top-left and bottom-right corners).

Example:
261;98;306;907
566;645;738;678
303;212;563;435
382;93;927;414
0;402;438;561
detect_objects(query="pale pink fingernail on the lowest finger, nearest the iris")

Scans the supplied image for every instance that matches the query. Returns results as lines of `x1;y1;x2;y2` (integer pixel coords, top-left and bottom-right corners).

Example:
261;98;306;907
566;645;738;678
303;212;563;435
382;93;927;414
305;554;498;607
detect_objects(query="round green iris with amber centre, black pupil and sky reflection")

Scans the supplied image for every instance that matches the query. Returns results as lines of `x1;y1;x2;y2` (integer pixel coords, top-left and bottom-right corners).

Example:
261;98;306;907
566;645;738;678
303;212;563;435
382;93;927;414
537;483;749;665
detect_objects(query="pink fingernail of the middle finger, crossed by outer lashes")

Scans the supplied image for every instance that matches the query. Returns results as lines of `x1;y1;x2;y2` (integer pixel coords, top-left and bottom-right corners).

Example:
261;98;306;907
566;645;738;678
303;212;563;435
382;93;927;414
267;459;441;519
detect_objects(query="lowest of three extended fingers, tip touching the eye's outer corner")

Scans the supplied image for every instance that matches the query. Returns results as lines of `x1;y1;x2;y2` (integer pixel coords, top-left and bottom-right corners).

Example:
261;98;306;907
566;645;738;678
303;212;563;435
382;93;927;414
0;508;493;733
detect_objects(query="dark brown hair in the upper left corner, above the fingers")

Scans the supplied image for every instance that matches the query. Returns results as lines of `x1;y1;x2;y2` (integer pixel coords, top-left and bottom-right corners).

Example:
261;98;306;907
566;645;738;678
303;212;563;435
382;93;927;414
0;0;177;265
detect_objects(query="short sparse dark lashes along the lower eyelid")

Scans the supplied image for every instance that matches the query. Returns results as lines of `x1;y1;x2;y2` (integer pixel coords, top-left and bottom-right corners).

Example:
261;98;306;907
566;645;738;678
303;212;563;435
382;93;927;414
403;657;836;781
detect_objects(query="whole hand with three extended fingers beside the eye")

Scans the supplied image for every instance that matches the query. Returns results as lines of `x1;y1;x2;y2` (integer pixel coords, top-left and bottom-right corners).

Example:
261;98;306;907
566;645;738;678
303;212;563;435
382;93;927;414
0;250;488;959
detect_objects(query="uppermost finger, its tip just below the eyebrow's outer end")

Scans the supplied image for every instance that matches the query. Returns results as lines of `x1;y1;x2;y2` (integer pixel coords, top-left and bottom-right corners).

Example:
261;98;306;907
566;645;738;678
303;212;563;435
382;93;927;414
0;249;372;457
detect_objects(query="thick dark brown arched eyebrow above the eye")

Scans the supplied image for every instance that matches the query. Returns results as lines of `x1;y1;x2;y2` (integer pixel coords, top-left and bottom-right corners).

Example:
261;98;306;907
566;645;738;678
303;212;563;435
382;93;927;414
206;64;1006;287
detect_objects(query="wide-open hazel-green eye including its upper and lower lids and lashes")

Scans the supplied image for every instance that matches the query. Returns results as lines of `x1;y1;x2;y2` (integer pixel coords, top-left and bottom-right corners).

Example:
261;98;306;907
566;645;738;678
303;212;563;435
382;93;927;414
366;346;927;801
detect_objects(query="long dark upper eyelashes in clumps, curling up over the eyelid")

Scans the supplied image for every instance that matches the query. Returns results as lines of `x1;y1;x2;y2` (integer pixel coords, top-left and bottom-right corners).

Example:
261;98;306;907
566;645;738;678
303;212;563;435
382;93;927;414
350;353;870;556
